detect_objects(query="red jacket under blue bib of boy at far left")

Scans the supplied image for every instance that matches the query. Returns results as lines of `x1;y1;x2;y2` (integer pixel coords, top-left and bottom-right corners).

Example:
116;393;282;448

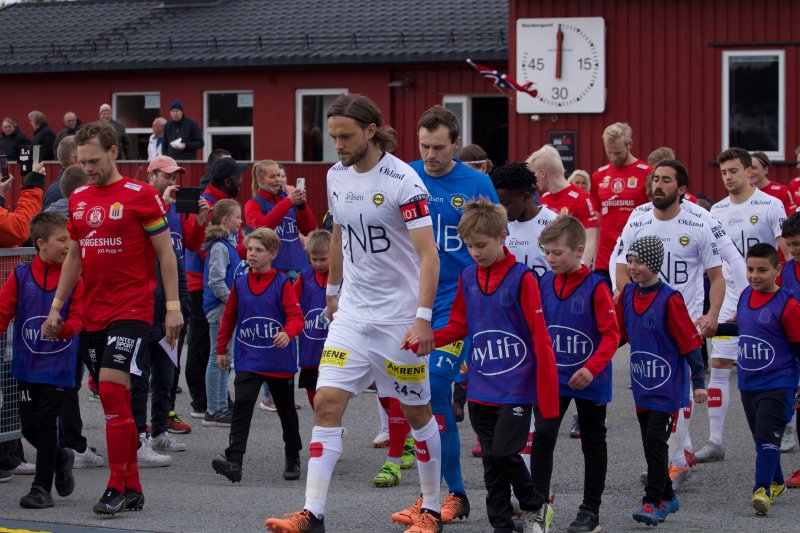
0;254;83;339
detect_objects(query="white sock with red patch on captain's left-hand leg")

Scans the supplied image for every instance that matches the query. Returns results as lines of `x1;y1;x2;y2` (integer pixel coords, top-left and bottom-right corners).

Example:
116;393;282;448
303;426;342;518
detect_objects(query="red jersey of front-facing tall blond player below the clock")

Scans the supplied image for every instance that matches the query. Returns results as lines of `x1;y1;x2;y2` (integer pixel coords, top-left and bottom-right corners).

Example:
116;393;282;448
592;159;653;270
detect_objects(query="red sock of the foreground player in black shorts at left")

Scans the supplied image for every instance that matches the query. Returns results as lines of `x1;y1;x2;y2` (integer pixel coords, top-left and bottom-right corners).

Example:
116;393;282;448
99;381;133;493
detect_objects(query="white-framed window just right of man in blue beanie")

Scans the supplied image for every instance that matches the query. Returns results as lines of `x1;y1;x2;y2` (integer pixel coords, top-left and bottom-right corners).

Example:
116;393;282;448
203;91;254;161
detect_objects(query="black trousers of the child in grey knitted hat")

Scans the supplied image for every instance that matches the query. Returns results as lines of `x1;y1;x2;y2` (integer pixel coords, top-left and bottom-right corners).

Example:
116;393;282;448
636;409;675;507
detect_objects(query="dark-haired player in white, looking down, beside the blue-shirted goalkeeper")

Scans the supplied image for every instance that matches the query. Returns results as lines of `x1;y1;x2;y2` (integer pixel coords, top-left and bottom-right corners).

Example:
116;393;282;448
492;163;558;278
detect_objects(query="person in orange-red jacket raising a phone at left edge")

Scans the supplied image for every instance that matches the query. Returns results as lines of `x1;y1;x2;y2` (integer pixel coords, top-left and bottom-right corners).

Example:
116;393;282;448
0;165;44;248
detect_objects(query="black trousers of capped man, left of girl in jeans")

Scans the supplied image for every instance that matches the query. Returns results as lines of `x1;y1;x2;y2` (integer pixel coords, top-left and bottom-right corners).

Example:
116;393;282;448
184;290;211;413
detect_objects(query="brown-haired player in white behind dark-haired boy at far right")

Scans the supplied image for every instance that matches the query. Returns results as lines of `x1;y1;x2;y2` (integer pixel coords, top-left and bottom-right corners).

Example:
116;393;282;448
695;148;789;463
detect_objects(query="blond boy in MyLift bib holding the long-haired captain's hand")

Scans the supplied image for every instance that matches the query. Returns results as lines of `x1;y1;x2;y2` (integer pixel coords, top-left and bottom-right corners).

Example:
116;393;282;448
434;199;559;531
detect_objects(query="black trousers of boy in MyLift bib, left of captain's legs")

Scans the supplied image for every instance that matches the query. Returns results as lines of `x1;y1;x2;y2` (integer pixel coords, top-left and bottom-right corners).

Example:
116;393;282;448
225;370;303;464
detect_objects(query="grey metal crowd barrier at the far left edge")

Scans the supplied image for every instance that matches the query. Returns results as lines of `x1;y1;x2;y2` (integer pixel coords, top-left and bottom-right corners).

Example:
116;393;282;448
0;248;36;442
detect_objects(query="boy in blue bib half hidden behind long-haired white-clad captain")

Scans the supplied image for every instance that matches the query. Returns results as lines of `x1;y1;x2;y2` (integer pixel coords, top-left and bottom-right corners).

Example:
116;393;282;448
294;229;331;409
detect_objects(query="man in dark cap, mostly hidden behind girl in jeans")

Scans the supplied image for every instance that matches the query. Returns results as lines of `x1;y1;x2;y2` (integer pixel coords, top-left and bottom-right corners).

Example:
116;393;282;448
184;156;247;418
